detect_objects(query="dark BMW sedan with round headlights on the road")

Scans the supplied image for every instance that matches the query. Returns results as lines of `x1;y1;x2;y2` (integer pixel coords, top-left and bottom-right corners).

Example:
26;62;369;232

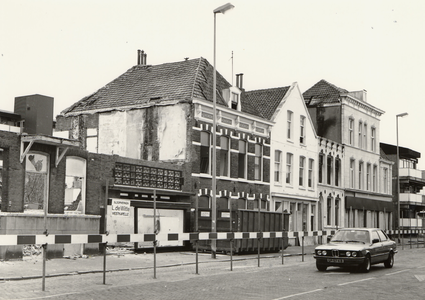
314;228;397;272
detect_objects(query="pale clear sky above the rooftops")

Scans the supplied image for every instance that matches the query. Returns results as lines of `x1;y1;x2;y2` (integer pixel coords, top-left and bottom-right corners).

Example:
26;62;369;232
0;0;425;170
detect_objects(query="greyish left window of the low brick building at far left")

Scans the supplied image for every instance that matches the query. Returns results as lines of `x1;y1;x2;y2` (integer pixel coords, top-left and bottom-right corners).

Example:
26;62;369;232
24;152;49;211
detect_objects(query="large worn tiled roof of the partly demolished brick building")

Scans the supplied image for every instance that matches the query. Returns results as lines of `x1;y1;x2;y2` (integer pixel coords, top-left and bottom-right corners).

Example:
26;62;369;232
61;57;238;115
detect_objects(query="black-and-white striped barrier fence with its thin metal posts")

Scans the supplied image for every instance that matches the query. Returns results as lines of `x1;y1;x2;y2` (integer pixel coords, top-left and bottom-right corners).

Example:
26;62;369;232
0;229;425;291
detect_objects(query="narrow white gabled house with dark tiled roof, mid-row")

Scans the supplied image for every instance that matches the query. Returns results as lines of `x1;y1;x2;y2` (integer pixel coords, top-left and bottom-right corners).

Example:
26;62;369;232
245;82;318;237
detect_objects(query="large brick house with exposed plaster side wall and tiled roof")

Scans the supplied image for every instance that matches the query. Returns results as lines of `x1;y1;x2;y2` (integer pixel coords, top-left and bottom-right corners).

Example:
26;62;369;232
56;51;273;253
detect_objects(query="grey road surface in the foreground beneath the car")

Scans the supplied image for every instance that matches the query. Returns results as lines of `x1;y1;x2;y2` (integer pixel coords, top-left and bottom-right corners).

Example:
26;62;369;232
0;248;425;300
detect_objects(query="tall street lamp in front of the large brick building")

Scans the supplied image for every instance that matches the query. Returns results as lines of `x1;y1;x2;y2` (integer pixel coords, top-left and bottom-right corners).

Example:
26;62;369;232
211;3;234;258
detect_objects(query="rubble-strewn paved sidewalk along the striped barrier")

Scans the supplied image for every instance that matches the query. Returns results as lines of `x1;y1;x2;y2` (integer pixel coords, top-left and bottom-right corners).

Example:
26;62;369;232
0;246;315;281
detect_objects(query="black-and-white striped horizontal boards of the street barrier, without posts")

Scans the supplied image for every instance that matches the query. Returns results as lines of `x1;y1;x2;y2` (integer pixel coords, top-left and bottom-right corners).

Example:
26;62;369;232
0;229;424;246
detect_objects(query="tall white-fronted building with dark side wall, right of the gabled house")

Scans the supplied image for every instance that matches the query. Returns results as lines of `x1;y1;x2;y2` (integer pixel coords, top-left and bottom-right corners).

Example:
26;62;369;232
303;80;394;229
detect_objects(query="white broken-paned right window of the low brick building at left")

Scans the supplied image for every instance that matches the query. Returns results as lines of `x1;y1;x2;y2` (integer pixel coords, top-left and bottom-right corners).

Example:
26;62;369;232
65;156;86;214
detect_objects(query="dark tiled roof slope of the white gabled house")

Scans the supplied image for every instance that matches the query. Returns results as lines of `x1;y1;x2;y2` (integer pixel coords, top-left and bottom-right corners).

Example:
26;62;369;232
242;86;290;120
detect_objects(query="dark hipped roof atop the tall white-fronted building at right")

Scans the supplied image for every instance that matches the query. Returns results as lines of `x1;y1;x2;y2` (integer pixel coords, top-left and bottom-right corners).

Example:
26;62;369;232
303;79;348;106
